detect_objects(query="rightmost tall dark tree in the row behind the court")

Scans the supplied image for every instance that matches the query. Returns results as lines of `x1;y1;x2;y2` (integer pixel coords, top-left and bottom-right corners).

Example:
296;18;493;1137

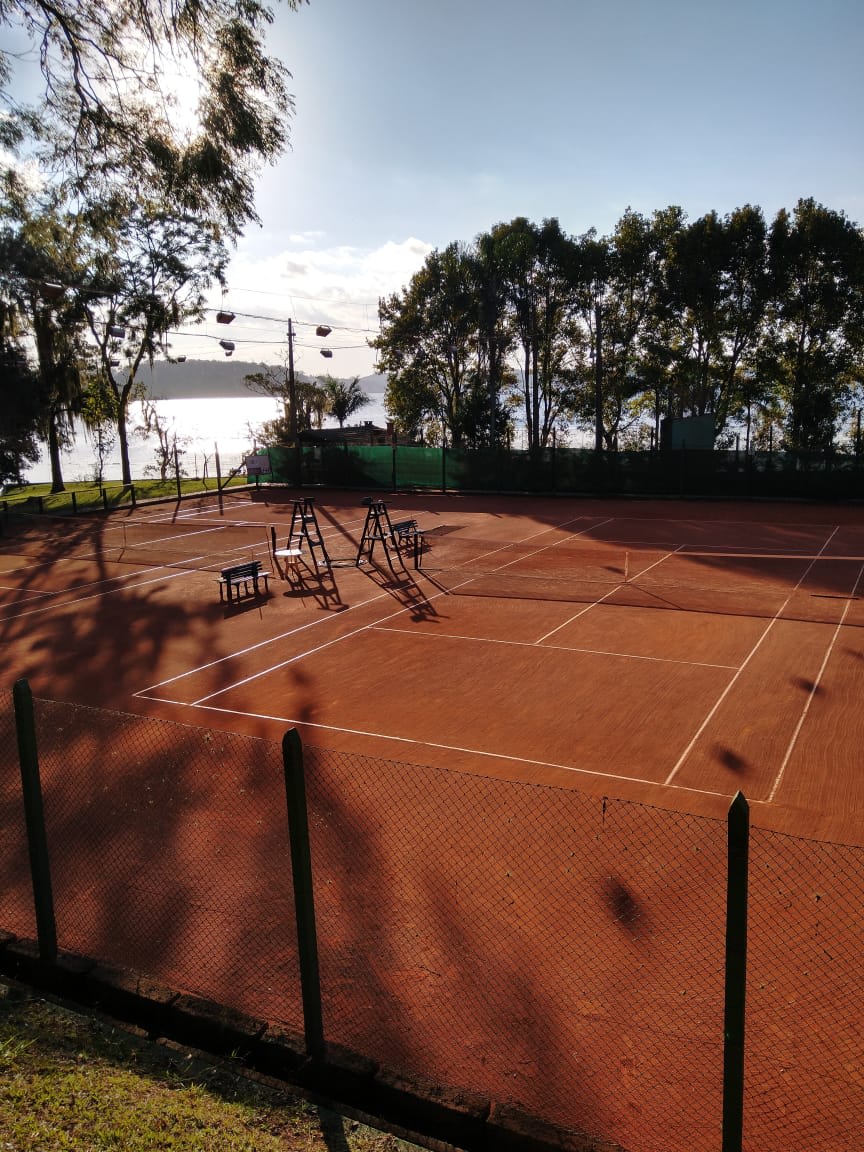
759;199;864;452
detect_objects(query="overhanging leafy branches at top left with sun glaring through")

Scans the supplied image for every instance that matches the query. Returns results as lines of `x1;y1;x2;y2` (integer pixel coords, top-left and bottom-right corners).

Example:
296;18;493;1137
0;0;302;235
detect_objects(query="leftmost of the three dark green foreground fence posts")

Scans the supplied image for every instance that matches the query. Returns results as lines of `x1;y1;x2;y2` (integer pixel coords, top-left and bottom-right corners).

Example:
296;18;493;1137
12;680;56;964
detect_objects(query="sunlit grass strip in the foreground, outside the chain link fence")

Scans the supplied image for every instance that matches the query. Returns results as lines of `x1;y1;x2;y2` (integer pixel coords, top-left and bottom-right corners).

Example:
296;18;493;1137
0;982;426;1152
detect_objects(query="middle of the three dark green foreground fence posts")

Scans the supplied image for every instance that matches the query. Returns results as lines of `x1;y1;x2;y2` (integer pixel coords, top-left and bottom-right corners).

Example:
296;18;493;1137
282;728;324;1059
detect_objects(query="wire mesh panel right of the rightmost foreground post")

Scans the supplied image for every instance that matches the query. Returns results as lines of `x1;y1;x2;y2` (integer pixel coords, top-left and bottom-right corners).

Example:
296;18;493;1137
744;828;864;1152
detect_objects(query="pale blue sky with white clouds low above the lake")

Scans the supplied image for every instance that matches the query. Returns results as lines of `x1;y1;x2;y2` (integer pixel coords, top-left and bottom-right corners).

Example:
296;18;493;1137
6;0;864;376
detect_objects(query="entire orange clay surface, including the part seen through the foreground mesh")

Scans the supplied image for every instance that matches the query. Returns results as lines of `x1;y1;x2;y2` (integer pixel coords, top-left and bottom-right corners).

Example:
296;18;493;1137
0;490;864;1152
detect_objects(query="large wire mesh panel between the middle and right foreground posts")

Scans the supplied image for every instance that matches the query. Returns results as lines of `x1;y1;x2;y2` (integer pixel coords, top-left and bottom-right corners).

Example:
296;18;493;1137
305;750;726;1150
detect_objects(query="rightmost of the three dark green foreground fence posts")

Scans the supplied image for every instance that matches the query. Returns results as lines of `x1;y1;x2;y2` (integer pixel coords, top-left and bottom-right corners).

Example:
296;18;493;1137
722;791;750;1152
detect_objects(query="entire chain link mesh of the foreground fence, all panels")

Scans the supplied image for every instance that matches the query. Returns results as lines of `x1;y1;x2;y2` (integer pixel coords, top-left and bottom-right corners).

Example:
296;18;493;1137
0;686;864;1152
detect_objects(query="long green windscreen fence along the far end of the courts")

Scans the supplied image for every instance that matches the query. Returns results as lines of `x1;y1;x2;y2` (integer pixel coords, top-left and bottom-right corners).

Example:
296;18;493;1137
250;444;864;500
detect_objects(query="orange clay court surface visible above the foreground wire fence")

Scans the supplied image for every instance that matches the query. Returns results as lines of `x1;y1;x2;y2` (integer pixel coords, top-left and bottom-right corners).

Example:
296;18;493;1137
0;490;864;836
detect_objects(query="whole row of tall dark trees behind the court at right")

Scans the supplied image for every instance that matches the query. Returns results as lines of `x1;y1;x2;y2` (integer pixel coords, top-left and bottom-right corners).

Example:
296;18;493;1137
372;200;864;453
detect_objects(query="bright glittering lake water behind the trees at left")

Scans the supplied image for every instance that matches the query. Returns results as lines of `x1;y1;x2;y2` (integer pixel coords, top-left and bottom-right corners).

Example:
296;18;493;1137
24;396;386;484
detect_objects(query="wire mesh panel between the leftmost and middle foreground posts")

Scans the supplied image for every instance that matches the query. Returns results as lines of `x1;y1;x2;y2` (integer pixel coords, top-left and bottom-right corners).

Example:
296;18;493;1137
5;700;302;1029
